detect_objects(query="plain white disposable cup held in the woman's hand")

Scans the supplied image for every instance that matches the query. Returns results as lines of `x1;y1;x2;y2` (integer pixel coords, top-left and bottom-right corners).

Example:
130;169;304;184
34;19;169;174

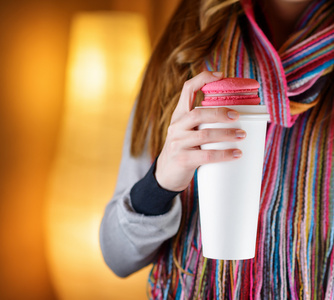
196;105;269;260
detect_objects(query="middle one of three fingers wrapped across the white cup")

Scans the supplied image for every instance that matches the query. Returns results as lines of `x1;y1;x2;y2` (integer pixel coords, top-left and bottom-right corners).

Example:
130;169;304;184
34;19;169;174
176;128;246;149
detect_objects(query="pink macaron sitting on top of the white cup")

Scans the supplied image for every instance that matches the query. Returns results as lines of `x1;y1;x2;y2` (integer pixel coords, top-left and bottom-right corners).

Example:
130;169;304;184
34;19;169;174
201;78;261;106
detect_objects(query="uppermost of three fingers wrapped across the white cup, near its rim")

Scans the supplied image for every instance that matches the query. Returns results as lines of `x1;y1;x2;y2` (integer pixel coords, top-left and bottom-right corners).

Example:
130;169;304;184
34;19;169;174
178;107;239;130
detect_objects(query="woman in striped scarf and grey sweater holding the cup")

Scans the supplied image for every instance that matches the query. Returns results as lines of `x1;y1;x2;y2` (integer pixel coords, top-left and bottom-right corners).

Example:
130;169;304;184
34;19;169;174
100;0;334;299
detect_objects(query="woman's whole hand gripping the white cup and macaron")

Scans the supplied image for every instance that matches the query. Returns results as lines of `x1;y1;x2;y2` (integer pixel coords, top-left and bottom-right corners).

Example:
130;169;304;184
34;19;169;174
155;71;246;191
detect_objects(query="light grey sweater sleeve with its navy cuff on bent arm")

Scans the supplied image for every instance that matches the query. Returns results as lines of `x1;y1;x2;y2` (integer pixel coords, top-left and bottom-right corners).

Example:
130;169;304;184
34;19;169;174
100;104;181;277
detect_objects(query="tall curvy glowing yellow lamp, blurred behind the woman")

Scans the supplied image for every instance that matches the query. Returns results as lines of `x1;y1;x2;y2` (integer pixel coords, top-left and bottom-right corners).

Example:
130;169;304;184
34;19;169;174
46;12;149;300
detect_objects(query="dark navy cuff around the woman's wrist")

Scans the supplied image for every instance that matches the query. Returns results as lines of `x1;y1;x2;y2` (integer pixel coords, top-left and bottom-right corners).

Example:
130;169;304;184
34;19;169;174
130;159;180;216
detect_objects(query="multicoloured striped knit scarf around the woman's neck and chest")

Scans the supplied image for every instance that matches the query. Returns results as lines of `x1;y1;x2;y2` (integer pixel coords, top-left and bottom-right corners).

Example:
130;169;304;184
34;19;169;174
149;0;334;300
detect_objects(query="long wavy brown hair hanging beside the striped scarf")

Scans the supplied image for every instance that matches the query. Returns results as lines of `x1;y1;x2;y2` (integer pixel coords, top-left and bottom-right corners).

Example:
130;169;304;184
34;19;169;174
131;0;239;157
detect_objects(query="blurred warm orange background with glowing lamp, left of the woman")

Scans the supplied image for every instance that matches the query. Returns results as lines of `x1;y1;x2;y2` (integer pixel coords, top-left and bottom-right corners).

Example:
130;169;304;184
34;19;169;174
0;0;179;300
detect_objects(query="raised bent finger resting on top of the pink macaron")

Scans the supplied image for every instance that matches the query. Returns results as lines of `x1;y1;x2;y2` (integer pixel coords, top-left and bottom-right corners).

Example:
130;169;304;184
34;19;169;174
171;71;223;118
